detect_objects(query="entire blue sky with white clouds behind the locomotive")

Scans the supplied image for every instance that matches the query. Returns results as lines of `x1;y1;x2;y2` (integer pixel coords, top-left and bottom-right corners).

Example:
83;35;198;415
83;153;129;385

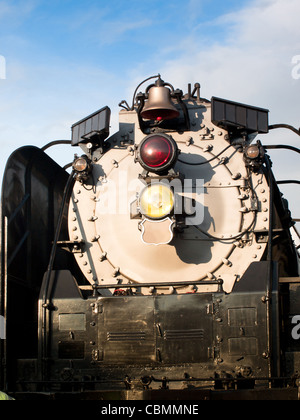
0;0;300;230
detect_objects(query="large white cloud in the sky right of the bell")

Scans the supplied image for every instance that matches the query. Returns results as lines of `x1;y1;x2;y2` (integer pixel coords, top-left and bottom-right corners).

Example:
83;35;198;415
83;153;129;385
152;0;300;226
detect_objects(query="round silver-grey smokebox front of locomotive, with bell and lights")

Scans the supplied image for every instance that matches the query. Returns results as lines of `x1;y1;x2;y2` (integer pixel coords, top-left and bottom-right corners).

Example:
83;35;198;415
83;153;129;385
69;78;270;295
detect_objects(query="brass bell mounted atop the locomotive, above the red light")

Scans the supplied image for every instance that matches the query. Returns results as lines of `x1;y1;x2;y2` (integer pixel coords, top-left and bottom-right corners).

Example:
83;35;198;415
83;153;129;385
141;79;179;121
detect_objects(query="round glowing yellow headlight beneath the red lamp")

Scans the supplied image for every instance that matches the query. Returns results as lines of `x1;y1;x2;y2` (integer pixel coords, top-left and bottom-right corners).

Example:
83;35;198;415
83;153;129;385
139;183;175;219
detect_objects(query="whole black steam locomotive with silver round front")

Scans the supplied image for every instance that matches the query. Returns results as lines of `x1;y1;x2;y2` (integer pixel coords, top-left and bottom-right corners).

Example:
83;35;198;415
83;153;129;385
0;75;300;400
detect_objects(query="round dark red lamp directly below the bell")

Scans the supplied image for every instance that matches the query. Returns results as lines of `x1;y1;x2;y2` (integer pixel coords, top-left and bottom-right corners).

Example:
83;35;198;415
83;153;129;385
138;134;178;172
